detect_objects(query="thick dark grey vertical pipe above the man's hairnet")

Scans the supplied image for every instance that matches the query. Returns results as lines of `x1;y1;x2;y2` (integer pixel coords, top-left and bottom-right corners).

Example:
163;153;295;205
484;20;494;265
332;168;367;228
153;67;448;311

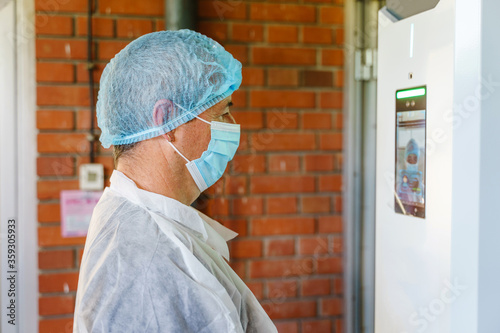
165;0;197;30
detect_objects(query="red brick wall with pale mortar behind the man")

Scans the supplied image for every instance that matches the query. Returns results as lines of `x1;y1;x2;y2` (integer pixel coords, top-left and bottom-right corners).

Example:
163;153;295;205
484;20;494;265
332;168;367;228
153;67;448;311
35;0;343;333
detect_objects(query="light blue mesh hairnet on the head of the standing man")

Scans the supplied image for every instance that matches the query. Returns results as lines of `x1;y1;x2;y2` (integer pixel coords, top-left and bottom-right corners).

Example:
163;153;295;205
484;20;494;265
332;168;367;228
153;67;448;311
97;30;241;148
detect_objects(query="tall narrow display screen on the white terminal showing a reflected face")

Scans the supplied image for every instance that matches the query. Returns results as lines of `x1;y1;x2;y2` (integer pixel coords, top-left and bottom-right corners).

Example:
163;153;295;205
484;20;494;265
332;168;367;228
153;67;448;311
394;86;427;218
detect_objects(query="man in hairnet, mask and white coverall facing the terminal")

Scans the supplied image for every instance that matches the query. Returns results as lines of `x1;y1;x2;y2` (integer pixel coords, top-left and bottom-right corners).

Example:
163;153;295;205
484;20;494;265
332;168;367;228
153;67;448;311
74;30;277;333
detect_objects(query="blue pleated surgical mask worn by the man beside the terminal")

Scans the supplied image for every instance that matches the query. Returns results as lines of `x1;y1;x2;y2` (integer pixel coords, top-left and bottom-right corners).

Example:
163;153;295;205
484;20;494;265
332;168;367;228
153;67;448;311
169;117;240;192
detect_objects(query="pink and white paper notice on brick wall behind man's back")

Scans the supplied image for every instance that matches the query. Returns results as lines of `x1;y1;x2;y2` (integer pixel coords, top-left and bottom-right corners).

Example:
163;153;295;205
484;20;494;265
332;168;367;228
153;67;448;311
61;190;103;237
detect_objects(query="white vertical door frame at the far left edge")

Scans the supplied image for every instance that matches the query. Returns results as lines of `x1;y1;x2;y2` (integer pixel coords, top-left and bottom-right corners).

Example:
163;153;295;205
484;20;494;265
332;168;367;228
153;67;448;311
0;0;38;333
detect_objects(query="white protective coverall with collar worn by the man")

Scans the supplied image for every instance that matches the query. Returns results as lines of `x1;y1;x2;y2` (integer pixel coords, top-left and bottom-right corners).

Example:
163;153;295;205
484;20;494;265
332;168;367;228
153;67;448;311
73;170;277;333
